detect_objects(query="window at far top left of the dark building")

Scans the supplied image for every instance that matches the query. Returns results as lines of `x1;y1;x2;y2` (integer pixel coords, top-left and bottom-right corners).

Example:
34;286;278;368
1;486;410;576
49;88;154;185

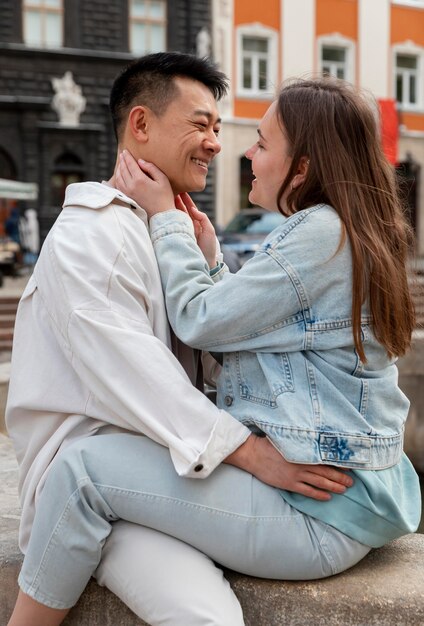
22;0;63;48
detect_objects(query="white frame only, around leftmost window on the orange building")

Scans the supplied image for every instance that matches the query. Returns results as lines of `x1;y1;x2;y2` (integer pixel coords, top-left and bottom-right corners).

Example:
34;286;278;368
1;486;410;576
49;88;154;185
236;22;278;100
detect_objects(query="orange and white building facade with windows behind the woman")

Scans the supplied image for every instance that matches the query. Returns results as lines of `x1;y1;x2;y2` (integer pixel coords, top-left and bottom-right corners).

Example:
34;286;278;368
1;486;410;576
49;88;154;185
212;0;424;256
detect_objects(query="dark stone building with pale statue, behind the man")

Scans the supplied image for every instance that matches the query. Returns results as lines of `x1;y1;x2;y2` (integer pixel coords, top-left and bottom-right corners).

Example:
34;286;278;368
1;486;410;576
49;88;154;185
0;0;213;239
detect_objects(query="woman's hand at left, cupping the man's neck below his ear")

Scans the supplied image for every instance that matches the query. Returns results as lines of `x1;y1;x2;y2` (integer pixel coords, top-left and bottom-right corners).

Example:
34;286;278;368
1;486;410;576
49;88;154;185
115;150;175;217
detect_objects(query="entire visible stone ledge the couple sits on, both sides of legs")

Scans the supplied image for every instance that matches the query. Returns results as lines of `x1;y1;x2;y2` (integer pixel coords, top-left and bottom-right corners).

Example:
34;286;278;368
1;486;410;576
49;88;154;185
0;435;424;626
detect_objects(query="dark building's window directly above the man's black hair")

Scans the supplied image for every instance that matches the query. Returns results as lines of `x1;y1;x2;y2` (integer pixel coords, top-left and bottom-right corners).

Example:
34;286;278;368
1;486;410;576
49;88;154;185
129;0;166;56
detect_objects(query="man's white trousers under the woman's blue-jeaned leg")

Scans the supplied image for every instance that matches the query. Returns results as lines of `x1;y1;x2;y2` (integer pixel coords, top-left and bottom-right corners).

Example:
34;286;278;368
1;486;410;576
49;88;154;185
95;521;244;626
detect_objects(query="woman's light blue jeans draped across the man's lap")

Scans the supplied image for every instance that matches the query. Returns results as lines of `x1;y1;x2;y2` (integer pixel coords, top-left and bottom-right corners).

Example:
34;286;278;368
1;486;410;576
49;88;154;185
19;434;370;608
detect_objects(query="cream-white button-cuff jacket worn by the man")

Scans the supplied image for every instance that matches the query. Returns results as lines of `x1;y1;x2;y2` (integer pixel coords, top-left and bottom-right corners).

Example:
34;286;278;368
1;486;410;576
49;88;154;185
6;182;250;551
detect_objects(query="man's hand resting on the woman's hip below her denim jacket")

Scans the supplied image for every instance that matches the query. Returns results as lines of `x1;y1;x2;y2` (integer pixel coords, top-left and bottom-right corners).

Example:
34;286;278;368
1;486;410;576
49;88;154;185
224;435;353;500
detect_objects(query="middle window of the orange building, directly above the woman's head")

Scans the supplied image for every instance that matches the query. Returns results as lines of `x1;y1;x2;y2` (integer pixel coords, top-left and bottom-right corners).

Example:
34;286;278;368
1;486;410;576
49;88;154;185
318;33;355;83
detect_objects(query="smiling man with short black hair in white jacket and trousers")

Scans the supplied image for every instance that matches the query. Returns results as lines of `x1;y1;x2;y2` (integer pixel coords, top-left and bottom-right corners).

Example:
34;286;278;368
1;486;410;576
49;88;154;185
6;53;349;626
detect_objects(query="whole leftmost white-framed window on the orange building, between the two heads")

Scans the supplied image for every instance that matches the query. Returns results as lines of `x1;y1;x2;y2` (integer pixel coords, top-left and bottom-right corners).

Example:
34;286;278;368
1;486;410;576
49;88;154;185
237;24;277;98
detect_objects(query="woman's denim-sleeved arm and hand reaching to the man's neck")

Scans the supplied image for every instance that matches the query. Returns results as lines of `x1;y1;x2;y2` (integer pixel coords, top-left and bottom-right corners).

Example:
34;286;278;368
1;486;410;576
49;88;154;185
116;154;303;352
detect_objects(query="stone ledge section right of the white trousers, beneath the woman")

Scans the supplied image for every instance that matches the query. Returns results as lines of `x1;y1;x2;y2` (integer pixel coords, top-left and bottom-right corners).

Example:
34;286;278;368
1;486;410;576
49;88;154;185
226;534;424;626
